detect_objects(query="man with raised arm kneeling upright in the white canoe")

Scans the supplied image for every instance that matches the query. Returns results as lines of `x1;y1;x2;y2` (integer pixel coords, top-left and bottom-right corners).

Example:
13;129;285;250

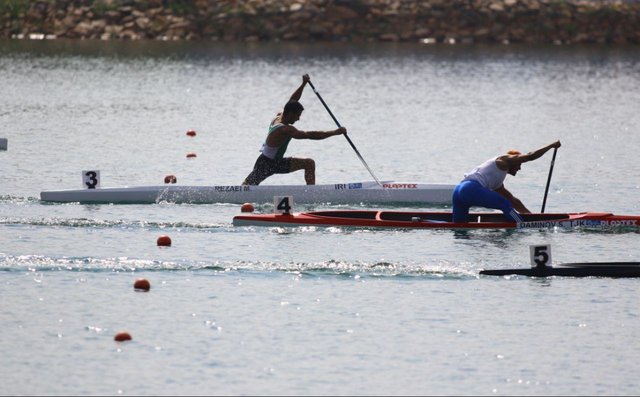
242;74;347;185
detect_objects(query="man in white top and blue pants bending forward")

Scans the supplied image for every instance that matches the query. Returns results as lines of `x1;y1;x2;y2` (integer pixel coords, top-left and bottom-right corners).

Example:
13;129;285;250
452;141;560;222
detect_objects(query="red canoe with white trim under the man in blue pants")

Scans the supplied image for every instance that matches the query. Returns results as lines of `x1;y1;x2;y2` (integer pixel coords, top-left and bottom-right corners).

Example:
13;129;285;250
233;210;640;229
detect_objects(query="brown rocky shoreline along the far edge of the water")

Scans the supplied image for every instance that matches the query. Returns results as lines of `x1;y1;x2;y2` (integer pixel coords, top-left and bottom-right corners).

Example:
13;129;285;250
0;0;640;44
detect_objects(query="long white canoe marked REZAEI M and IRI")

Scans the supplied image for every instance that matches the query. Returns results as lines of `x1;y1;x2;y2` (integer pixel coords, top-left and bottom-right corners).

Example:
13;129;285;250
40;181;455;204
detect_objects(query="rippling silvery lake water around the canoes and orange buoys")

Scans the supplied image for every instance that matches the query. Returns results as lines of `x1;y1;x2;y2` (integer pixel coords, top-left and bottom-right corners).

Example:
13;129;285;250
0;40;640;395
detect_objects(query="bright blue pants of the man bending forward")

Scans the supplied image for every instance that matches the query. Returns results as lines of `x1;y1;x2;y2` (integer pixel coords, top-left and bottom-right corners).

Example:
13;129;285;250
451;181;522;222
